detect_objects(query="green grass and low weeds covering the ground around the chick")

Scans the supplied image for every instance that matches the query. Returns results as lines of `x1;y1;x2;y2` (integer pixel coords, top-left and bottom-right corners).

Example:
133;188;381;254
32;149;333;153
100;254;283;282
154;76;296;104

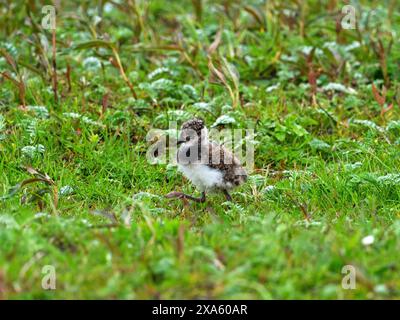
0;0;400;299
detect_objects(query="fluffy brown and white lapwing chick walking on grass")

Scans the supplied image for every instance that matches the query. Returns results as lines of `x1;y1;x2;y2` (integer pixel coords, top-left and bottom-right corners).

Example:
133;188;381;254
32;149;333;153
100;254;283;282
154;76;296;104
166;118;247;202
